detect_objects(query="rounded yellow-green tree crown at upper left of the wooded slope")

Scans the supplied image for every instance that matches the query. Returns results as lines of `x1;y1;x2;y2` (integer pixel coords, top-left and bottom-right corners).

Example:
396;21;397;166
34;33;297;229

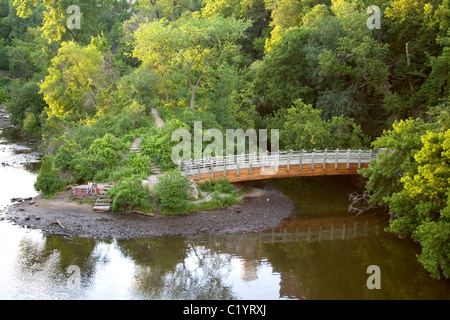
40;38;116;122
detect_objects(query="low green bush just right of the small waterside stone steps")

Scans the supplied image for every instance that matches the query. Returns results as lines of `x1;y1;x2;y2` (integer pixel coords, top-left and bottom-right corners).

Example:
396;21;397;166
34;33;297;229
108;175;153;213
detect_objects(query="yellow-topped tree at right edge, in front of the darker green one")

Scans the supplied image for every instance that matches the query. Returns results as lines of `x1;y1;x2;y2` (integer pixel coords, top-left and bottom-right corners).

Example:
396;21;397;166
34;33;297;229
389;129;450;278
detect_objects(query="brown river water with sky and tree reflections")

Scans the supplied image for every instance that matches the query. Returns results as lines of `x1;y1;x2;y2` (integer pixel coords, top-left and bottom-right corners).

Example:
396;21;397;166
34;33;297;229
0;127;450;299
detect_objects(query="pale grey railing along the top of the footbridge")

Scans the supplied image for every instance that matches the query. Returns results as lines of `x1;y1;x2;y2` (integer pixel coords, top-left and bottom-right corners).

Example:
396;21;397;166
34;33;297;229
178;149;377;176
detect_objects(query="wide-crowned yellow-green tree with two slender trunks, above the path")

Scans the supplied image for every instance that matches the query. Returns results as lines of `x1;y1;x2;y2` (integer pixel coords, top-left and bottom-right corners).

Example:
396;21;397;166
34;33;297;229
133;16;249;108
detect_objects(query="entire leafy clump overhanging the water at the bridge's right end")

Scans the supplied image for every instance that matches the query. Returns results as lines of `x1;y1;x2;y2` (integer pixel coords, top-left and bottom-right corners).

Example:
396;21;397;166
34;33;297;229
361;105;450;278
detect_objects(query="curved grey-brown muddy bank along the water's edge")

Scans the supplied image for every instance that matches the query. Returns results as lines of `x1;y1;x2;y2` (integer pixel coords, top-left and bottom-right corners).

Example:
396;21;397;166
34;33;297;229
5;184;294;239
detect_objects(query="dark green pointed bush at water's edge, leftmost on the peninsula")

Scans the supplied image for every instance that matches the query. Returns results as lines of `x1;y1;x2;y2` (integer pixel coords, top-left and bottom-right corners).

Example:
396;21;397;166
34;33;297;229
34;155;65;197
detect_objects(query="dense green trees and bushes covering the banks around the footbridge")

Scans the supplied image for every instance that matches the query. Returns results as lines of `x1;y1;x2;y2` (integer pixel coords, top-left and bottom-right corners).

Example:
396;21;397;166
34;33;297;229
0;0;450;277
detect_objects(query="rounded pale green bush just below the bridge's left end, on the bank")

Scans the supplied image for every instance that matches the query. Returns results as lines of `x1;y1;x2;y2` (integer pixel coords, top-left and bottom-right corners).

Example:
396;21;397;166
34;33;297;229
155;169;192;214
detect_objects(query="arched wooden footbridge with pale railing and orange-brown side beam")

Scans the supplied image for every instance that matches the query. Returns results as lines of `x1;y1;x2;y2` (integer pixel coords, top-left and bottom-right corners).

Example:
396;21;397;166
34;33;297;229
178;149;377;183
